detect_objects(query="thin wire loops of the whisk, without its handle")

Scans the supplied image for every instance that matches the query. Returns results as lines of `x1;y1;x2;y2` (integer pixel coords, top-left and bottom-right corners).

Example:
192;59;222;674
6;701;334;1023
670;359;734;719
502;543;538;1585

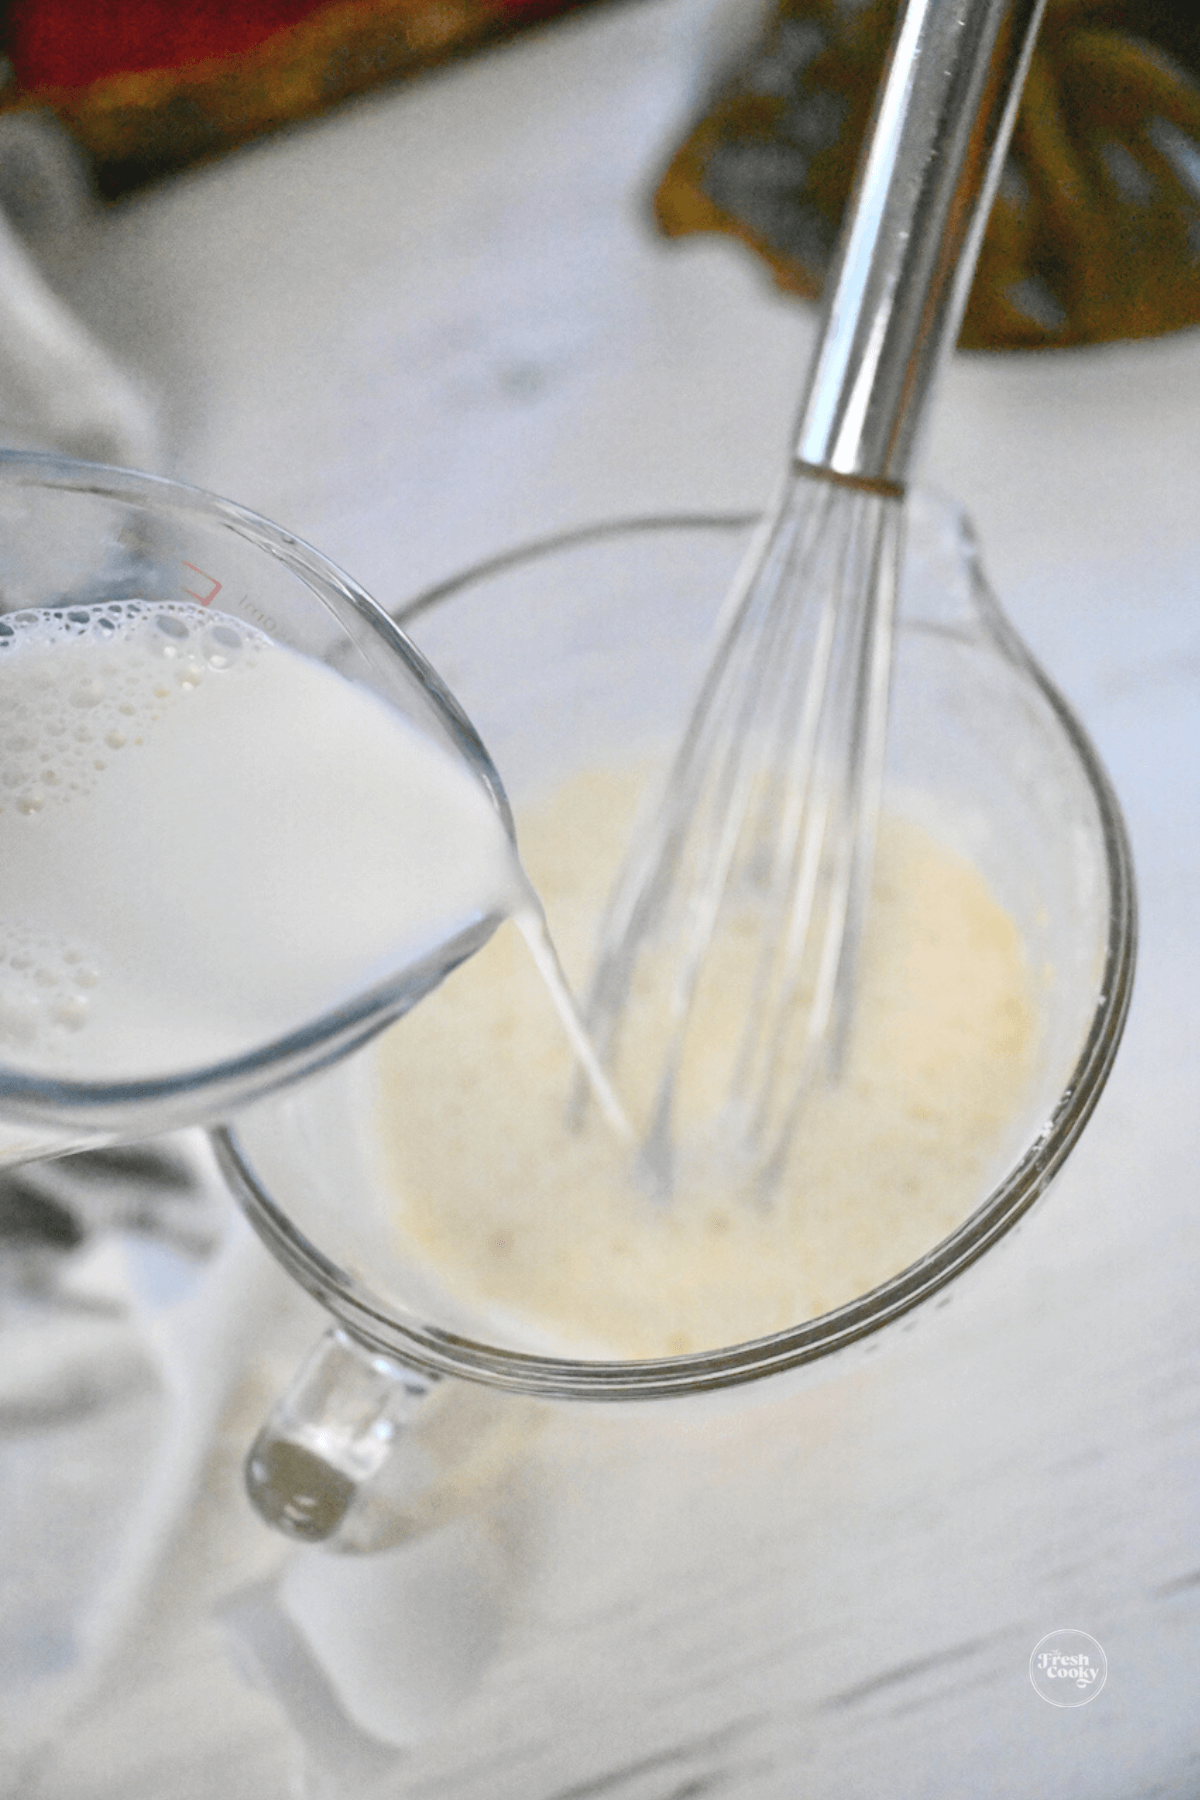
587;472;898;1193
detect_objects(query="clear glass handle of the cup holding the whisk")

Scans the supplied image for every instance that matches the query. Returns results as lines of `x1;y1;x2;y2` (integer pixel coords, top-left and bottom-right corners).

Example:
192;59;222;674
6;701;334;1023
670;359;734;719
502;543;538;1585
245;1327;437;1544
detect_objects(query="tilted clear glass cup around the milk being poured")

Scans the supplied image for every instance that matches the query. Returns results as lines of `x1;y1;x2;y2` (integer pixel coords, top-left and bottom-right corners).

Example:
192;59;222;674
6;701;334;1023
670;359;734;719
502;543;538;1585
0;452;509;1163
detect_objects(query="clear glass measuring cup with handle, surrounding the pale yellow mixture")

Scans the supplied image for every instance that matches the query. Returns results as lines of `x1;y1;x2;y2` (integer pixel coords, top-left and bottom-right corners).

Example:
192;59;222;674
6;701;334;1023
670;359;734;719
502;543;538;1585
216;497;1135;1543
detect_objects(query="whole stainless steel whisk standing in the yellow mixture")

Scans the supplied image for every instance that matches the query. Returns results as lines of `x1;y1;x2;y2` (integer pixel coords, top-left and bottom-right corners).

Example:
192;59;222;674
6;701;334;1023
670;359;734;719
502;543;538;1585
585;0;1043;1193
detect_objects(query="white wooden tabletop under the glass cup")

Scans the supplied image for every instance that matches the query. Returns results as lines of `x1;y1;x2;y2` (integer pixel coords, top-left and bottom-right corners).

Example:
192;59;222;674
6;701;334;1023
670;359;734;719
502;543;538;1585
2;0;1200;1800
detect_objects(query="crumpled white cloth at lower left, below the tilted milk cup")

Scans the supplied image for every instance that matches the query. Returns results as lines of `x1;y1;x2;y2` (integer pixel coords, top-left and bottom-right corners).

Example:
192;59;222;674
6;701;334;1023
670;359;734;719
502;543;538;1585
0;1134;275;1771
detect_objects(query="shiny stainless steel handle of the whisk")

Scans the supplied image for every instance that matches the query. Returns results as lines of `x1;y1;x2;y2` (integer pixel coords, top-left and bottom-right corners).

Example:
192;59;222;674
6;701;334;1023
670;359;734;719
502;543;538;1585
795;0;1045;490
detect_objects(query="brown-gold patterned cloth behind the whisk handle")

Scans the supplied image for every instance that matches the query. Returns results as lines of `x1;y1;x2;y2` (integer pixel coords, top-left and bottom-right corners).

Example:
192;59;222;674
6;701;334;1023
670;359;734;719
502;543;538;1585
655;0;1200;349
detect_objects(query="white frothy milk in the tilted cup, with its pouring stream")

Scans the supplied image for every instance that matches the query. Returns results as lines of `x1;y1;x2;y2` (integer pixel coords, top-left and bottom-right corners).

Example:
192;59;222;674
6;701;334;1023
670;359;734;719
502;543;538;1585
0;601;615;1116
